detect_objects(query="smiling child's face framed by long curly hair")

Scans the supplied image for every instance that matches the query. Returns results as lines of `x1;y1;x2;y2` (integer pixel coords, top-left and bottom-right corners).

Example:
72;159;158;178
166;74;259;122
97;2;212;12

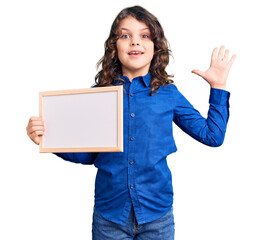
116;17;154;80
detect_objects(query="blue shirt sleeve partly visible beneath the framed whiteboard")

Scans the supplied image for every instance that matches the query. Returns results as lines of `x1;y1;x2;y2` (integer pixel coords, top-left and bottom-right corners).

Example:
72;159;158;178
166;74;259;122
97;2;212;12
54;152;98;165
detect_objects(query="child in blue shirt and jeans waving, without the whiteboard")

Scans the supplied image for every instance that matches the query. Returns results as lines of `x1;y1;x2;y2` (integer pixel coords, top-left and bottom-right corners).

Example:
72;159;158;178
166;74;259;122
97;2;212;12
27;6;236;240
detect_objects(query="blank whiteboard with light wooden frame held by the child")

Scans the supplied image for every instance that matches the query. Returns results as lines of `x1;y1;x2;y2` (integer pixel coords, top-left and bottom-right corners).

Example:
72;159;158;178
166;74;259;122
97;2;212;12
39;85;123;152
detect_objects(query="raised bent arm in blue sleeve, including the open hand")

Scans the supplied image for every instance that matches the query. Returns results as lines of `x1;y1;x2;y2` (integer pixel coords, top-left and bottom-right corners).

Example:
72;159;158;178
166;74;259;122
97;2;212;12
173;46;236;147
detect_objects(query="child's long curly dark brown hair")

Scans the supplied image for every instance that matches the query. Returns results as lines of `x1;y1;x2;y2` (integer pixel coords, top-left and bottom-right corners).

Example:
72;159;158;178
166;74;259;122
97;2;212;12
95;6;174;96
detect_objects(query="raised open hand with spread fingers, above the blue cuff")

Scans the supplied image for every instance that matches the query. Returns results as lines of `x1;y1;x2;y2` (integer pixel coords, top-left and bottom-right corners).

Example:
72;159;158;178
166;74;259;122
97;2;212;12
192;46;236;90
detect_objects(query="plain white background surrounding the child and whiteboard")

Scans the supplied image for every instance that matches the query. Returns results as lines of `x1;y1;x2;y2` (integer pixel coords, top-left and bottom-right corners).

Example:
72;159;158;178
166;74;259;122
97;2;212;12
0;0;262;240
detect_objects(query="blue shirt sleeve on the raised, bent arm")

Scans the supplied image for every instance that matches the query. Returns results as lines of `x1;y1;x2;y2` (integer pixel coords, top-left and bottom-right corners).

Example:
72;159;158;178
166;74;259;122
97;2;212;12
173;87;230;147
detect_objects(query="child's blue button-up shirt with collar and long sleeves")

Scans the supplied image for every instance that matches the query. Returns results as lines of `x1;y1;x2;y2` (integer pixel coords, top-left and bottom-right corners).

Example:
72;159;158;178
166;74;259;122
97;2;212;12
56;73;229;225
